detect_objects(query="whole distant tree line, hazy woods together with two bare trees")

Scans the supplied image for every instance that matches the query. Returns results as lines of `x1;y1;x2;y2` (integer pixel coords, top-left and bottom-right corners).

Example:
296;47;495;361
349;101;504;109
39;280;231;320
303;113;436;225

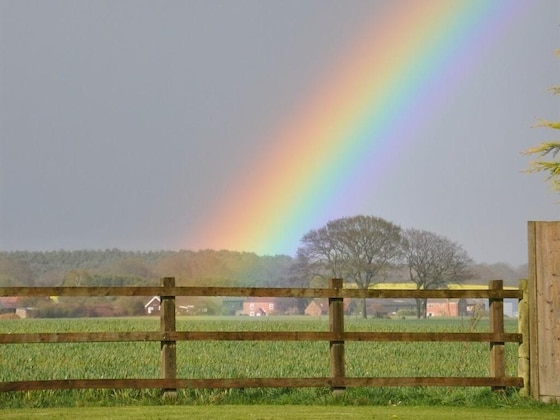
0;215;527;317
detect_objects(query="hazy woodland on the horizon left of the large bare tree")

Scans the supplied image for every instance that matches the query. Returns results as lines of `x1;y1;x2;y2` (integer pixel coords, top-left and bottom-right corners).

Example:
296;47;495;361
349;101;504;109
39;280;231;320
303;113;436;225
0;249;292;286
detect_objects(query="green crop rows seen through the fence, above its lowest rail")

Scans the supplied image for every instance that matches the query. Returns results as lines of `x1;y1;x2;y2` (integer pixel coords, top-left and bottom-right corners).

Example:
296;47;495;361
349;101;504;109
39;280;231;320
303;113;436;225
0;317;517;381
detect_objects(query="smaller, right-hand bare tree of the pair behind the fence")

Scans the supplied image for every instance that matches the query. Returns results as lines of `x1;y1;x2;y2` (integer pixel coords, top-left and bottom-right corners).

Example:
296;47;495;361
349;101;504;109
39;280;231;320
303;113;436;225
403;229;472;318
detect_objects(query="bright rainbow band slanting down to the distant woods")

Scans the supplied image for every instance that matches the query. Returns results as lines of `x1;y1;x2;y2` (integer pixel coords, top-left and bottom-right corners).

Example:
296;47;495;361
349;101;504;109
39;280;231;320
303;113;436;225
185;0;530;255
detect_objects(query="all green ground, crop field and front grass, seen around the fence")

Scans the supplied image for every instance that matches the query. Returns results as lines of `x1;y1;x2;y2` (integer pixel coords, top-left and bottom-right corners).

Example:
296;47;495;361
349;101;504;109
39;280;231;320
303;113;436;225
0;317;560;420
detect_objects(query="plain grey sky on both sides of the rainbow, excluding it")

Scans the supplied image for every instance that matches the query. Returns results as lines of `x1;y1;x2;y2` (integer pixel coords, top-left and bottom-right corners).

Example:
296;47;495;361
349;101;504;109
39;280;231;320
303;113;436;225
0;0;560;264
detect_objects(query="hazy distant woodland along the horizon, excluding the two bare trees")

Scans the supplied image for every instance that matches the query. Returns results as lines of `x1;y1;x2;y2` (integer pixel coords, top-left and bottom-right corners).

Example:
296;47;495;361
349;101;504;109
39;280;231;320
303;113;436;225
0;249;527;317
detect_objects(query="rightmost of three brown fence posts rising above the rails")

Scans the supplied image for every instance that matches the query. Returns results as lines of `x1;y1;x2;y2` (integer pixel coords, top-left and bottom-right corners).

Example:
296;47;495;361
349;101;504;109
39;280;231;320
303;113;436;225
488;280;506;391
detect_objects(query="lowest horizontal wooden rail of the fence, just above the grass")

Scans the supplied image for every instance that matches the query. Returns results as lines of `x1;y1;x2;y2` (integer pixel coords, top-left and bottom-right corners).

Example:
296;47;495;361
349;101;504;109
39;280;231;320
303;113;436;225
0;377;523;392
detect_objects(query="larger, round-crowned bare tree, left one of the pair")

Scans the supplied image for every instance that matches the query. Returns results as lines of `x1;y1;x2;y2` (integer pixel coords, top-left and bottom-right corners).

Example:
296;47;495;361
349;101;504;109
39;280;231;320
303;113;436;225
297;216;401;318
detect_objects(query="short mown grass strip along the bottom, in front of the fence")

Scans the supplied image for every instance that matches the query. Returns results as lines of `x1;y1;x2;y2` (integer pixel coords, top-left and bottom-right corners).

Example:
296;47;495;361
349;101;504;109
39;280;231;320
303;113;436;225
0;405;560;420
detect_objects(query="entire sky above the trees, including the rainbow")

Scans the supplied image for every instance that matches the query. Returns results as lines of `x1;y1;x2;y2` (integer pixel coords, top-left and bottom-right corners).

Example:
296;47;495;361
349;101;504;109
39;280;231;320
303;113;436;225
0;0;560;266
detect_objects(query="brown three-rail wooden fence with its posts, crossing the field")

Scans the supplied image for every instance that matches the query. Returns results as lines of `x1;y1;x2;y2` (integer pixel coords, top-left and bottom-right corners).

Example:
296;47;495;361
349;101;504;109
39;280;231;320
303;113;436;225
0;277;529;392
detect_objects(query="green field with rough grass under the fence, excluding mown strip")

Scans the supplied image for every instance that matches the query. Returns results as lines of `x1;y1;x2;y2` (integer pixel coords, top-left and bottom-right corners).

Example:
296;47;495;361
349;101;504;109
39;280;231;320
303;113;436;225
0;317;556;408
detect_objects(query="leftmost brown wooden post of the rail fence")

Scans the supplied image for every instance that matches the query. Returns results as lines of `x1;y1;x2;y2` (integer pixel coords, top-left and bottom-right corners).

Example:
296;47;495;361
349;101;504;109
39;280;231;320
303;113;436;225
160;277;177;398
